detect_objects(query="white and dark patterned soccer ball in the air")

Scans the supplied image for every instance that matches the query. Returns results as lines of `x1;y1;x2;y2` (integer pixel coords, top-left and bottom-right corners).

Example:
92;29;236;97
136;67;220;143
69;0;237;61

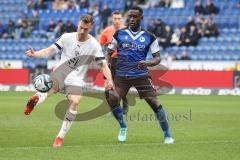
34;74;53;93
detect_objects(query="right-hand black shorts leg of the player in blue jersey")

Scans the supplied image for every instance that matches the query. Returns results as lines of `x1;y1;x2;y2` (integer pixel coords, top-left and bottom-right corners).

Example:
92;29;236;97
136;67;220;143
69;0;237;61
132;76;157;99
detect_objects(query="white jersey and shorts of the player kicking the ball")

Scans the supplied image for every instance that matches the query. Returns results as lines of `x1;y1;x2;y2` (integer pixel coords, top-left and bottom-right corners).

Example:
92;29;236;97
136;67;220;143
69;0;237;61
51;32;105;86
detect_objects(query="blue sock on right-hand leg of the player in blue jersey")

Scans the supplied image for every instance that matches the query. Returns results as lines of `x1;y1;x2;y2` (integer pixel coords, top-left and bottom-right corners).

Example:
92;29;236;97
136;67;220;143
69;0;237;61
156;108;172;138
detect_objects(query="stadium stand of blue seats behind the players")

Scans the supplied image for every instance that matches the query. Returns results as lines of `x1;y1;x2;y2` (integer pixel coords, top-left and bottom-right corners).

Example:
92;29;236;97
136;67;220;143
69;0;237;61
0;0;240;69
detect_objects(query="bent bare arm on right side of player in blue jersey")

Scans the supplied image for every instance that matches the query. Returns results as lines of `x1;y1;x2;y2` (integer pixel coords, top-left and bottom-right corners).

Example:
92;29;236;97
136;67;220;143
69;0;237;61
138;52;161;69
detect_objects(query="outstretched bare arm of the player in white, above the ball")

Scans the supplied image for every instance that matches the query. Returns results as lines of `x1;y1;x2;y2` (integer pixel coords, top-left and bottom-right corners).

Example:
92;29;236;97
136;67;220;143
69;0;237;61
25;46;55;58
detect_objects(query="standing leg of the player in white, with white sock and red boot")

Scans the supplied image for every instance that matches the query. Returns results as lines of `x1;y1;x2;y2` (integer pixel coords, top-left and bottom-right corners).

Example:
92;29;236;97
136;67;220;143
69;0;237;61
53;95;82;147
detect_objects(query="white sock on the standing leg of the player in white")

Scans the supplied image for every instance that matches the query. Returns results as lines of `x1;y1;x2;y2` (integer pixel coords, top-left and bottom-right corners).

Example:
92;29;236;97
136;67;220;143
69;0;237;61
57;109;77;138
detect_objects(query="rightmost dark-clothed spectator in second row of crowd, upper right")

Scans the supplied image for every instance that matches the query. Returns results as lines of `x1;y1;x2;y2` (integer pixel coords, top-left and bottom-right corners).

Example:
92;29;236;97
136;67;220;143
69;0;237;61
205;17;219;37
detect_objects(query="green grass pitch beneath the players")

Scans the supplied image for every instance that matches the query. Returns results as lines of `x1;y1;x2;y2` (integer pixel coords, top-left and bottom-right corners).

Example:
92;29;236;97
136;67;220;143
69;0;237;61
0;92;240;160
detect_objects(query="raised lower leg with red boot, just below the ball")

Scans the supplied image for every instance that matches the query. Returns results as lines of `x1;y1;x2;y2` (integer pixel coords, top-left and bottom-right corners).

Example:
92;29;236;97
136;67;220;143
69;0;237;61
24;88;55;115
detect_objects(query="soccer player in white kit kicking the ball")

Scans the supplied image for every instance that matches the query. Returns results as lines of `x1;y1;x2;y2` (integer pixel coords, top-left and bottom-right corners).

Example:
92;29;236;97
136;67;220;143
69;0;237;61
24;15;113;147
